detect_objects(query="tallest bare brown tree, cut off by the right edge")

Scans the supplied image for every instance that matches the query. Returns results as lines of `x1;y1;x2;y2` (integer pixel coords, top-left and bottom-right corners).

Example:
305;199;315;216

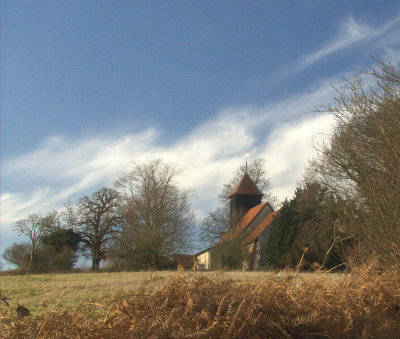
311;60;400;268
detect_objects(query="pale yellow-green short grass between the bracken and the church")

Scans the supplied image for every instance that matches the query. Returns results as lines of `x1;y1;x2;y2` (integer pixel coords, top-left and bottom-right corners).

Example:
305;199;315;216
0;271;300;316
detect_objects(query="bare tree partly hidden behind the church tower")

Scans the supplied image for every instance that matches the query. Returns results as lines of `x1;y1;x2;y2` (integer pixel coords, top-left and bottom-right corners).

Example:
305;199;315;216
200;158;279;246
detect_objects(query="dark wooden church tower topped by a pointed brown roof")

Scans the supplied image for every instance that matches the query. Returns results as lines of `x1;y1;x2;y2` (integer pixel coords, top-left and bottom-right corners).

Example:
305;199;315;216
229;172;263;228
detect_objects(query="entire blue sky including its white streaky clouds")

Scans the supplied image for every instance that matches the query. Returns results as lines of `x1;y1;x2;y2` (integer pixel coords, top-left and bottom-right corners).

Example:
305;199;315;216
0;0;400;266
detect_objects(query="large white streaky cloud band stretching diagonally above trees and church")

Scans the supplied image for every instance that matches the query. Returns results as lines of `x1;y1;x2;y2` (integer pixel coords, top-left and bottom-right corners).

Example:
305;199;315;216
1;79;338;228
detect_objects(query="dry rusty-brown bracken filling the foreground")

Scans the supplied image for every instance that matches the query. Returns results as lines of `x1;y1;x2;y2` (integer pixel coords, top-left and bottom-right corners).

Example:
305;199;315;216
1;265;400;338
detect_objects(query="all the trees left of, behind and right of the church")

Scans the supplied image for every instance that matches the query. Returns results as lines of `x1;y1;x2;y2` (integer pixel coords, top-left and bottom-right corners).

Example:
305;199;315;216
3;60;400;271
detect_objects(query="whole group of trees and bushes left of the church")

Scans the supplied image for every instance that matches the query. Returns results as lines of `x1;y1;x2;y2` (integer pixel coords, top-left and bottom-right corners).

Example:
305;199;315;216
3;159;194;273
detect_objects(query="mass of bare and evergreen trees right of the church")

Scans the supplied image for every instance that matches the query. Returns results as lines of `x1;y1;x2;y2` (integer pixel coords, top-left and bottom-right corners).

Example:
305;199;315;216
267;60;400;268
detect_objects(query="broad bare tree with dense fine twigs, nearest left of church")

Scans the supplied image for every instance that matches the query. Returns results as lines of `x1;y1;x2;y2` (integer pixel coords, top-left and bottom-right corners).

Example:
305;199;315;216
115;159;194;268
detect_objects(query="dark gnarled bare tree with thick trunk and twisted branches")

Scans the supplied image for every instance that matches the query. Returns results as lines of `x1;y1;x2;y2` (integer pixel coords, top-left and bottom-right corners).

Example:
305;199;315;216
76;187;121;270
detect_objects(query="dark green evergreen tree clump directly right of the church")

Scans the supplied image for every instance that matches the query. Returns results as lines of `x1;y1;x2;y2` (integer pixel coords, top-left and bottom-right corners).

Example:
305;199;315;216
266;182;349;268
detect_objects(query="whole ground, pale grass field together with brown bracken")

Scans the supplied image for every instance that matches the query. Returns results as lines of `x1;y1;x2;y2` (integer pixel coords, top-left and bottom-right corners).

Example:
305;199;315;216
1;267;400;338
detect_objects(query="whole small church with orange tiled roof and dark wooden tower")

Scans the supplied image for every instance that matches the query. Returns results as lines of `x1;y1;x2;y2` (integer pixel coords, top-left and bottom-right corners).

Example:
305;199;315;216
195;172;279;270
